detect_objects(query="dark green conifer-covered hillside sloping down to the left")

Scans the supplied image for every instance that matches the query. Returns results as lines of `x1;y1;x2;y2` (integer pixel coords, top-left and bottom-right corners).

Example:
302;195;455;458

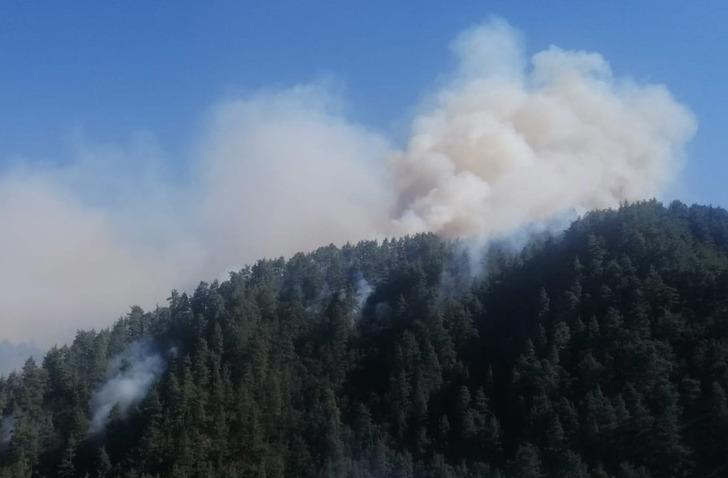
0;201;728;478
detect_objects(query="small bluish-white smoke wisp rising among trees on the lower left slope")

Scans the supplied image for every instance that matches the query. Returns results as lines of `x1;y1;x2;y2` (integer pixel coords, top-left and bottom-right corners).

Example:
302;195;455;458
89;339;165;434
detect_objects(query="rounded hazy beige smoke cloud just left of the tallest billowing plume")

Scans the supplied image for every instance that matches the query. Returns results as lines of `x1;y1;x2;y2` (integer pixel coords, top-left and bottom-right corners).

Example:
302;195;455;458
197;85;390;273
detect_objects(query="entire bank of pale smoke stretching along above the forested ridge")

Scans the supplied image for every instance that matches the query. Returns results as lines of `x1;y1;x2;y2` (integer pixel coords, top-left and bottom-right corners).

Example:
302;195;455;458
0;20;696;348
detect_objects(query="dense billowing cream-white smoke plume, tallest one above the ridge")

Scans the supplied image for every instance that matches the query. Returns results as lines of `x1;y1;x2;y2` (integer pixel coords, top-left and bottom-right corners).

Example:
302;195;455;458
393;20;696;236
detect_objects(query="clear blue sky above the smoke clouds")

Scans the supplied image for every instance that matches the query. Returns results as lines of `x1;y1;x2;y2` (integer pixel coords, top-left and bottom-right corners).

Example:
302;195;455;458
0;0;728;206
